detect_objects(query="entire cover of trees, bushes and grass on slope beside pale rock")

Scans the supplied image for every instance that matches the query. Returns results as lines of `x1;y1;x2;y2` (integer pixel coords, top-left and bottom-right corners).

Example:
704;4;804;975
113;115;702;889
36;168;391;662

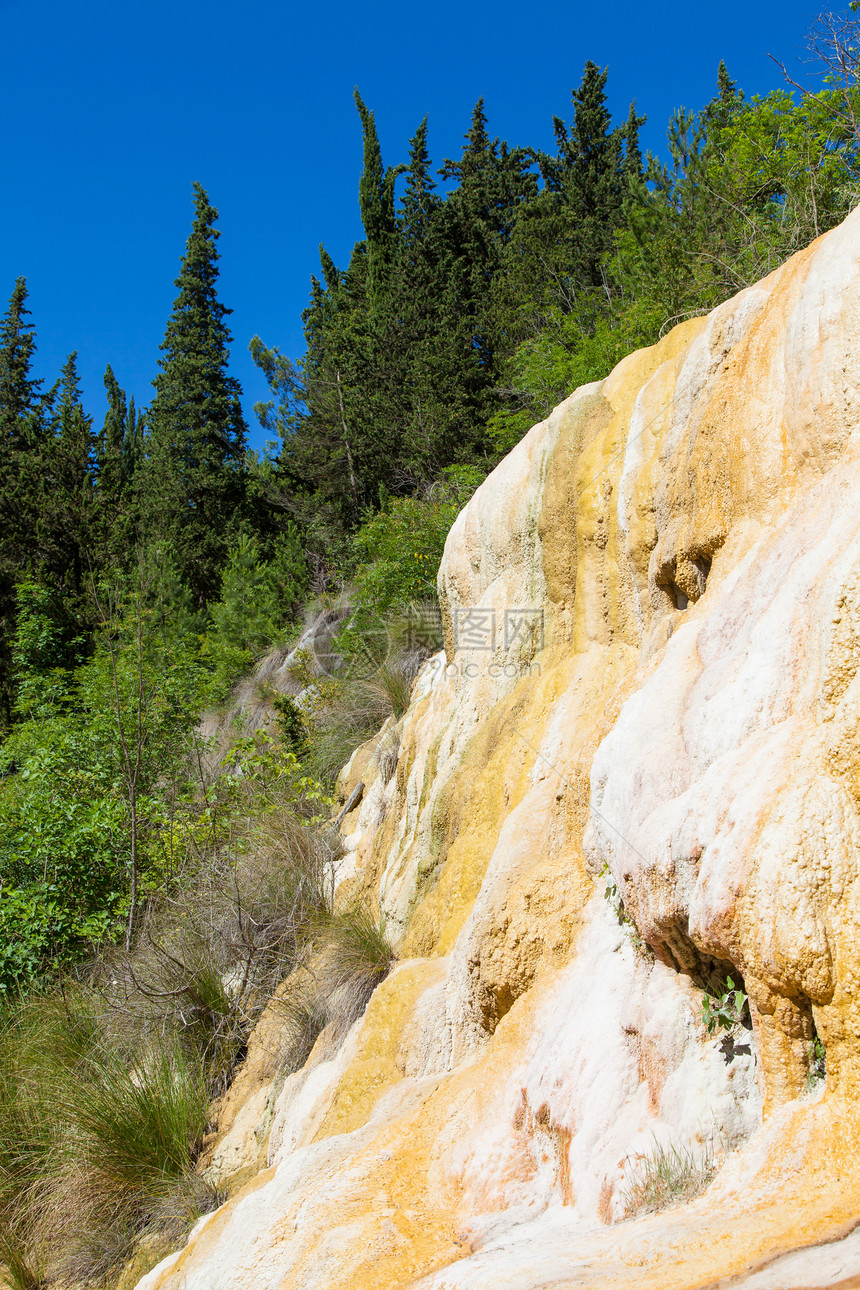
0;17;860;1290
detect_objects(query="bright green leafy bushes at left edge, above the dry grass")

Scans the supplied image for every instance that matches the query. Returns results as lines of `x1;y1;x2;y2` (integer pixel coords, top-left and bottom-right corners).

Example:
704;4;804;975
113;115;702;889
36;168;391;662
0;588;205;991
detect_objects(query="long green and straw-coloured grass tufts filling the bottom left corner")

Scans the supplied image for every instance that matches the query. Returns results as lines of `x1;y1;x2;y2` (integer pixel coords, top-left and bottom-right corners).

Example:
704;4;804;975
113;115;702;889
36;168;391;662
0;986;219;1290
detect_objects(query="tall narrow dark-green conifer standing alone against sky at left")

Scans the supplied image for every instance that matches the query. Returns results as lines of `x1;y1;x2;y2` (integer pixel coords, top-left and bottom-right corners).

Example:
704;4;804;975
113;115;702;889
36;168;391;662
142;183;246;605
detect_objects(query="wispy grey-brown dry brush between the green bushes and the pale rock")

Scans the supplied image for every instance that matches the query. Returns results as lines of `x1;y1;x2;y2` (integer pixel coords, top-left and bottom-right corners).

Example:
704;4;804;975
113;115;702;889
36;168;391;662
101;811;339;1095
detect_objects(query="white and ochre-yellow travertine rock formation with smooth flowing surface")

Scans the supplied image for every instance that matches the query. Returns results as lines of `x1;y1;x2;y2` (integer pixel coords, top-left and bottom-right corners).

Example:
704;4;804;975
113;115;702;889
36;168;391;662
141;212;860;1290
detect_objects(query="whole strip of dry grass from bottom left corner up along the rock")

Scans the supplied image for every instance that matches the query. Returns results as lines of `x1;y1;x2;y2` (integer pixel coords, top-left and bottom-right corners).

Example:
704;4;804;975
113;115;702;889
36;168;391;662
0;841;393;1290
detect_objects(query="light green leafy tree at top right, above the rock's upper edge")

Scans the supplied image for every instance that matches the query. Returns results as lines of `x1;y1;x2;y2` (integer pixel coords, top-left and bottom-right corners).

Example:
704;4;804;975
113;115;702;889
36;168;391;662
619;76;857;319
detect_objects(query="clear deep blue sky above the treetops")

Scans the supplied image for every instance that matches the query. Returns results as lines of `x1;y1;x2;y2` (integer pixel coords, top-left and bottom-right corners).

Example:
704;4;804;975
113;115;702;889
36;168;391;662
0;0;817;446
